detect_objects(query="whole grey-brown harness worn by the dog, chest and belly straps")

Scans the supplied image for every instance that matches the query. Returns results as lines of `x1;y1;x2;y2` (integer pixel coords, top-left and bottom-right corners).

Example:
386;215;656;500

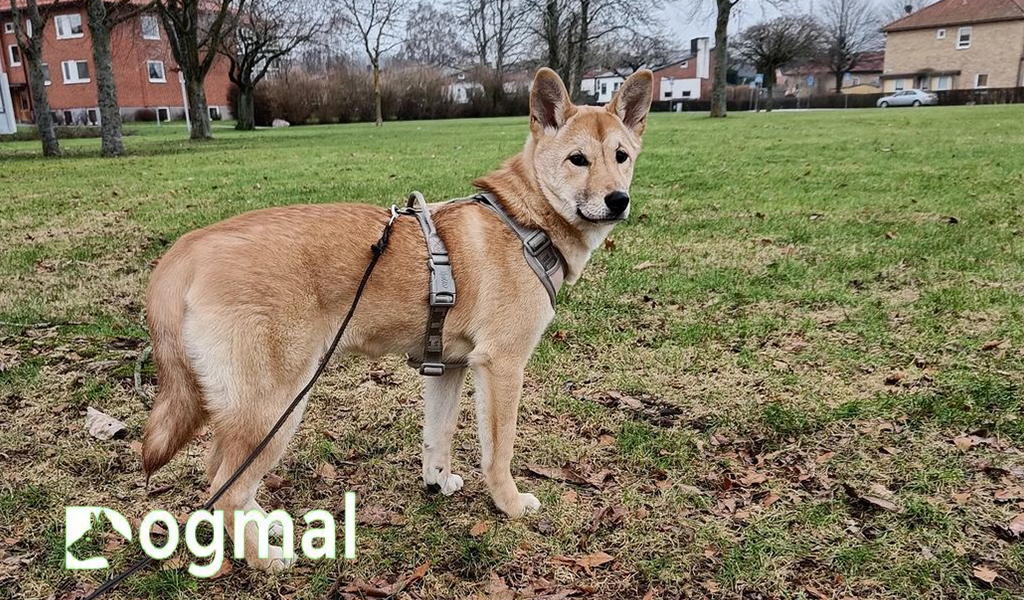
392;191;565;377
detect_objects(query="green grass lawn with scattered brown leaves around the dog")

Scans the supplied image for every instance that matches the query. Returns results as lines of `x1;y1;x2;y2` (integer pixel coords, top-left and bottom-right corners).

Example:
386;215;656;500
0;105;1024;599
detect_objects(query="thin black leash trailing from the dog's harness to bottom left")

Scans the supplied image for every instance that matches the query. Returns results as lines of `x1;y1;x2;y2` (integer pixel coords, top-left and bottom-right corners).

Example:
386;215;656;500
85;206;402;600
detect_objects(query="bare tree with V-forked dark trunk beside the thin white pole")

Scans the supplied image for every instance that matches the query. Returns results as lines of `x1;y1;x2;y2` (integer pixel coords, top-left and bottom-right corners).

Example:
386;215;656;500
156;0;246;139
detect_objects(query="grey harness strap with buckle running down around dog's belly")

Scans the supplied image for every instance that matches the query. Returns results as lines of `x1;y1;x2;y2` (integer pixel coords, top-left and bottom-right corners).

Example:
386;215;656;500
400;191;455;377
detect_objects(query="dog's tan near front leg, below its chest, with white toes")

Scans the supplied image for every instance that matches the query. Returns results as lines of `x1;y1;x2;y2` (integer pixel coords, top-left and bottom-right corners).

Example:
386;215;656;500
473;361;541;517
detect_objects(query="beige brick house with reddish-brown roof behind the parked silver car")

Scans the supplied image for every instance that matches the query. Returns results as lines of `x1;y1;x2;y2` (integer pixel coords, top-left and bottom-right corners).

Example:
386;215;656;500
882;0;1024;92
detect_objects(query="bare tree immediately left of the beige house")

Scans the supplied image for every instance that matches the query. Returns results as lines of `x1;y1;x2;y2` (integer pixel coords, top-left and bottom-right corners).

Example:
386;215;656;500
821;0;882;93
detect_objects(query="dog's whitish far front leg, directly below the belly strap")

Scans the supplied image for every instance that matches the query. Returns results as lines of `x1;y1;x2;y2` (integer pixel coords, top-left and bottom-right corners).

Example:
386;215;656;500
423;369;466;496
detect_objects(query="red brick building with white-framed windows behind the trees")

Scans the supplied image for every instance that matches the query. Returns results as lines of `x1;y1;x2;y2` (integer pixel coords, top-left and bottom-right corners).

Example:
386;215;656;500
0;0;230;124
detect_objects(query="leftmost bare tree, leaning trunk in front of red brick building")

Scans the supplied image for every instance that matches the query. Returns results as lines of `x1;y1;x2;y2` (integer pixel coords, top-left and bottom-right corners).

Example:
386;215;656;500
10;0;60;157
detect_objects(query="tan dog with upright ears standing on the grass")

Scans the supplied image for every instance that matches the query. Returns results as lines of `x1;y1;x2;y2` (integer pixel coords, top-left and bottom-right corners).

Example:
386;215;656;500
142;69;652;570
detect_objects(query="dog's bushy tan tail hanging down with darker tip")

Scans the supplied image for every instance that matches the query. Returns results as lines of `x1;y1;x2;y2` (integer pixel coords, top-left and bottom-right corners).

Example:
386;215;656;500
142;242;206;478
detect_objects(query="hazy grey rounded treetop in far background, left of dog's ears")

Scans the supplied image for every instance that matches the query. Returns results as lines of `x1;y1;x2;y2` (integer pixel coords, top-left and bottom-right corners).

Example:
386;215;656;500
400;0;468;67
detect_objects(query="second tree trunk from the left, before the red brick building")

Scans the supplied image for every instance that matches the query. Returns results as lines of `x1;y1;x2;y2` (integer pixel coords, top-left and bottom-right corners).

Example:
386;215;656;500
86;0;125;157
